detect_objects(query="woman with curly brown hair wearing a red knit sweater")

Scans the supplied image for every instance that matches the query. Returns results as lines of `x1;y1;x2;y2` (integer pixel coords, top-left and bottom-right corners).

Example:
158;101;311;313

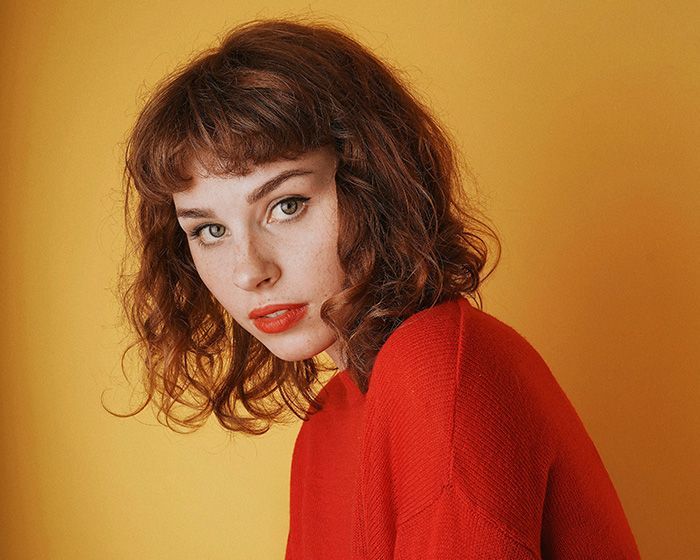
119;21;639;559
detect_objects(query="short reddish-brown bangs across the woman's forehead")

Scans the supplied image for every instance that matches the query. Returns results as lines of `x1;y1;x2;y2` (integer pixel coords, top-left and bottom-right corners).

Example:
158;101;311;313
126;64;333;203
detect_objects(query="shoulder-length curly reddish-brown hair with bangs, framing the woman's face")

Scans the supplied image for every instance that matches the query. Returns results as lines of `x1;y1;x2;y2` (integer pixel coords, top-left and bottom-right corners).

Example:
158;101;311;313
122;20;500;434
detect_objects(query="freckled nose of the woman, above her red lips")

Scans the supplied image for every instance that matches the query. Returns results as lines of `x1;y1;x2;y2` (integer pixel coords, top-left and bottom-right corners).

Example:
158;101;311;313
232;237;281;291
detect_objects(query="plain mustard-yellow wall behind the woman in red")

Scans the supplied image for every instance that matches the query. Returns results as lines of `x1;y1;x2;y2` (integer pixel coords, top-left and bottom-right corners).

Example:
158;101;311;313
0;0;700;560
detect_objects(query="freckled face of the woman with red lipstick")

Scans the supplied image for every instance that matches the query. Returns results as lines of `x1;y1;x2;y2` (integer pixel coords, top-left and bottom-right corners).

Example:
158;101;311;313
173;148;345;368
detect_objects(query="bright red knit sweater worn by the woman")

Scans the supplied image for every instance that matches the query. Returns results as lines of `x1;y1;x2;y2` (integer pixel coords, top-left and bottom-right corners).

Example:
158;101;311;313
286;299;639;560
